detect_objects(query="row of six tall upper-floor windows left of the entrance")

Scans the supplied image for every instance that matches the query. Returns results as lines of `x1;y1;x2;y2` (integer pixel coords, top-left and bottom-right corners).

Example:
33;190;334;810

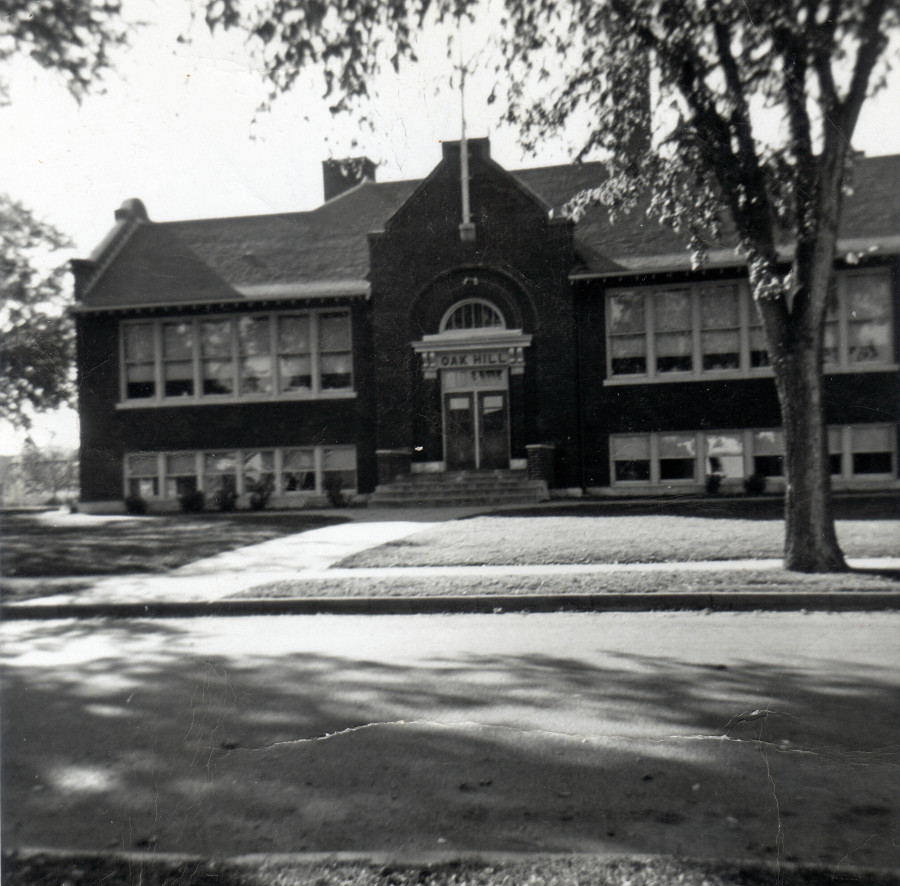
121;311;353;402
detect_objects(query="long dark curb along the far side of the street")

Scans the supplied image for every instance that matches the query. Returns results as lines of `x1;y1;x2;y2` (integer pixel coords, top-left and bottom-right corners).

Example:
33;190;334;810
0;591;900;621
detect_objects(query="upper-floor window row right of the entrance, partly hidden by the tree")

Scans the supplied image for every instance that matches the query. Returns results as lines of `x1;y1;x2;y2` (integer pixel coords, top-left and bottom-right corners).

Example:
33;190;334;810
607;269;894;378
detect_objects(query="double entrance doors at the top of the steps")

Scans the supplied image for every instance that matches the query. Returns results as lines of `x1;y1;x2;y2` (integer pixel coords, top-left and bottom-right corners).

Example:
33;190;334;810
444;391;509;471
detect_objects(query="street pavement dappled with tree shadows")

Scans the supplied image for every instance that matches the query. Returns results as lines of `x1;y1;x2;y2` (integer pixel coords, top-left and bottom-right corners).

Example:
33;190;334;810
0;613;900;868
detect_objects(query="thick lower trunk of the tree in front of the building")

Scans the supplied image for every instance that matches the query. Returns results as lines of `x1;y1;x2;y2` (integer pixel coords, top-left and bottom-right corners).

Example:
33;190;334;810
775;345;847;572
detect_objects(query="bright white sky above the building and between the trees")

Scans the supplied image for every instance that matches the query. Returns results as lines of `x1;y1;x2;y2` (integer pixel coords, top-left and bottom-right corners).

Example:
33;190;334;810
0;0;900;453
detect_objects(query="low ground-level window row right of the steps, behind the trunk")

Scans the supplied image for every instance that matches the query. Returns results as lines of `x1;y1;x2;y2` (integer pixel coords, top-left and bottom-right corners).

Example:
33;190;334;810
610;425;897;485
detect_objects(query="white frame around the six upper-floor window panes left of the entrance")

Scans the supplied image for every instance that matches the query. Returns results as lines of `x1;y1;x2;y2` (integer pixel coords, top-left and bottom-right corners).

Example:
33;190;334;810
117;307;356;409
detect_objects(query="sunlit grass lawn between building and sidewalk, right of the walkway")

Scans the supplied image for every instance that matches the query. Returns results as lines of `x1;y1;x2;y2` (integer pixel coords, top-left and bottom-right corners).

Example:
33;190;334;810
337;495;900;568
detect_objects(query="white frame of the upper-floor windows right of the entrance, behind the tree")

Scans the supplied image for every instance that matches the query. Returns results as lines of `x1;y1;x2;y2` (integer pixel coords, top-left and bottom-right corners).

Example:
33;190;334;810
603;267;898;385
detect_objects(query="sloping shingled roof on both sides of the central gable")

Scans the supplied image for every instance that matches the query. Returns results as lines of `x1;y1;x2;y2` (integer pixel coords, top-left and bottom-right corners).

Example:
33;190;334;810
77;155;900;309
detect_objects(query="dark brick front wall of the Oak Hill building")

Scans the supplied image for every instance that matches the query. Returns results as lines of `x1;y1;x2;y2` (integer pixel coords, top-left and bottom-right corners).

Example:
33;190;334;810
76;140;900;502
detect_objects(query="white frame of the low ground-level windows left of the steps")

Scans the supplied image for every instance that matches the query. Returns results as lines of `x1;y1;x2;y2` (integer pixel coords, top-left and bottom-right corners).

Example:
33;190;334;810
122;444;359;502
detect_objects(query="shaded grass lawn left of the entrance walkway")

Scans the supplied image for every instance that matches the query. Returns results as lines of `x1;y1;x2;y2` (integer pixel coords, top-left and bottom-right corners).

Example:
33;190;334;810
0;511;344;579
